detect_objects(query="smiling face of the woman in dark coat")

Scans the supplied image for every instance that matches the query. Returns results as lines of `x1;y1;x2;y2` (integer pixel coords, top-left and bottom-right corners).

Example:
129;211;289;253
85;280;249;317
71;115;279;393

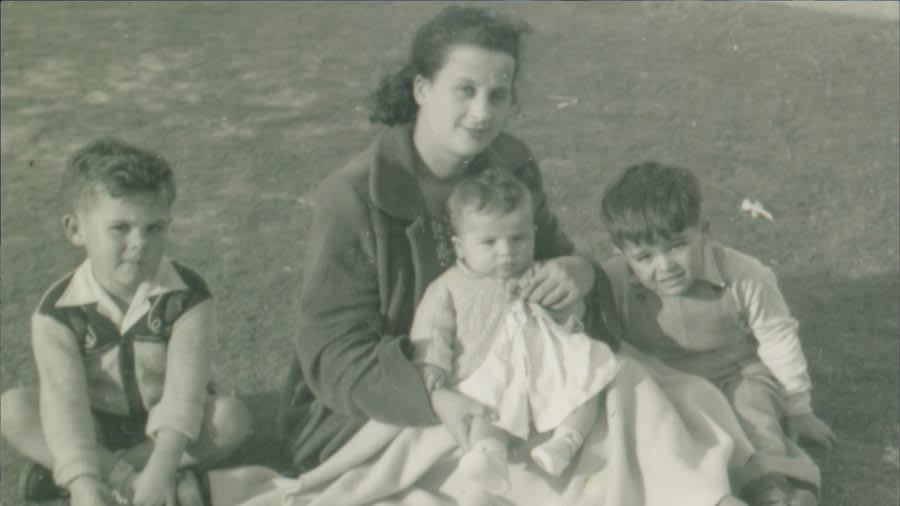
413;45;516;175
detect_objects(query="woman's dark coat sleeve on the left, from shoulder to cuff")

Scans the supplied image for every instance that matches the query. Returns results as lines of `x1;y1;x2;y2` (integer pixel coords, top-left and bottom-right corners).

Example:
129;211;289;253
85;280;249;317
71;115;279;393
294;177;437;425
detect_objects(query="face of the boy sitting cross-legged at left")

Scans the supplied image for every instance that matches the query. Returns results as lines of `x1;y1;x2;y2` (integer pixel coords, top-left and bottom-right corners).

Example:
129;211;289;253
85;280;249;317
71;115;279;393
63;185;170;303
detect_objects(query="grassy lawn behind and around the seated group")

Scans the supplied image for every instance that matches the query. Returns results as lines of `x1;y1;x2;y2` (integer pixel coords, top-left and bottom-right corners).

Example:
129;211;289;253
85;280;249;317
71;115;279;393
0;2;900;506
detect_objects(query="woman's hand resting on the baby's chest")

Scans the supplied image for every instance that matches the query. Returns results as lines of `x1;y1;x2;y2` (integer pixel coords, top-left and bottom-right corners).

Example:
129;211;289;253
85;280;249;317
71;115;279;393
522;256;594;309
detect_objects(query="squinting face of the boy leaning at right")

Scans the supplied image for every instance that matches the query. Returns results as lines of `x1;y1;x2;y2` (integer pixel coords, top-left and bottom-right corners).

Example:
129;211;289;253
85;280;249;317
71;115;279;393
620;226;704;296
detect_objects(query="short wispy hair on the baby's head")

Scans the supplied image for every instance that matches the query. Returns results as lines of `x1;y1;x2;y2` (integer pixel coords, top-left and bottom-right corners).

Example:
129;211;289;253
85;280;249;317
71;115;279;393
447;169;534;232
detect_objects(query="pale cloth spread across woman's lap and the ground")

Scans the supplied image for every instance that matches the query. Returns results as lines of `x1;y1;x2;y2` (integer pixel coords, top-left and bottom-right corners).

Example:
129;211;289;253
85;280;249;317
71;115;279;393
210;347;752;506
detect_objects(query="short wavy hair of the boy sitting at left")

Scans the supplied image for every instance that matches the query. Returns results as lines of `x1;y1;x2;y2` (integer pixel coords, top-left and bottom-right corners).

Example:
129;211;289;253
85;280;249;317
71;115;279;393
63;137;175;207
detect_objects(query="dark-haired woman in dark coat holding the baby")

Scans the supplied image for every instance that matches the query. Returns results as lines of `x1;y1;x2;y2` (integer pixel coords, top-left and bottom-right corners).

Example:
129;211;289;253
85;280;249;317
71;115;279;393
274;3;594;471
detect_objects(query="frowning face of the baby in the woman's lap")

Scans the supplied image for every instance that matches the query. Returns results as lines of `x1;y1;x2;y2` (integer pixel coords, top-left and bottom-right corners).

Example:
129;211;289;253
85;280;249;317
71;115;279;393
453;205;534;279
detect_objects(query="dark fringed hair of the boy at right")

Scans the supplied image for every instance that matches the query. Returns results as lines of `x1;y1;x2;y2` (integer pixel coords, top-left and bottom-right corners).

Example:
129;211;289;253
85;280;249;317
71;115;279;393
602;162;701;248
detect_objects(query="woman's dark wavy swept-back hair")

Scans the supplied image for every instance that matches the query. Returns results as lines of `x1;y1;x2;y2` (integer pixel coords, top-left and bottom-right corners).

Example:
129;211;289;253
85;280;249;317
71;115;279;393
369;5;529;125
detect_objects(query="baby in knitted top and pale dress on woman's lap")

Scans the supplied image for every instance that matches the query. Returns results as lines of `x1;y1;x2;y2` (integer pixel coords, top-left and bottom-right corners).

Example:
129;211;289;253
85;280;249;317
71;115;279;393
410;170;618;494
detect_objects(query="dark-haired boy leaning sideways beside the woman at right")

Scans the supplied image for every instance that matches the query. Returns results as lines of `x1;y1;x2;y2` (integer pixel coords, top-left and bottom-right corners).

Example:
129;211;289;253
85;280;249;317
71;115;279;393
602;162;835;506
